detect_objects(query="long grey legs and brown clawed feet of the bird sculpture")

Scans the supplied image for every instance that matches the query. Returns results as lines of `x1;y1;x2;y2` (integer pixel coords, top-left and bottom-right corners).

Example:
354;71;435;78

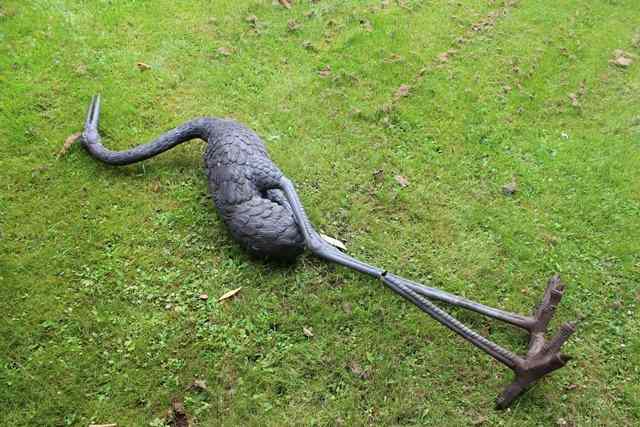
279;177;575;409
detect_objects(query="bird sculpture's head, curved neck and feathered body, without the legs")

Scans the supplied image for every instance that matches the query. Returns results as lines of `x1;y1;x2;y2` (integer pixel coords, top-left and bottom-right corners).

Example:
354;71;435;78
82;105;305;259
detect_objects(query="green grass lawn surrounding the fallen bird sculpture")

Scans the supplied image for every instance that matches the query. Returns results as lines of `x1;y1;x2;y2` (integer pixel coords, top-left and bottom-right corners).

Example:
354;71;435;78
0;0;640;427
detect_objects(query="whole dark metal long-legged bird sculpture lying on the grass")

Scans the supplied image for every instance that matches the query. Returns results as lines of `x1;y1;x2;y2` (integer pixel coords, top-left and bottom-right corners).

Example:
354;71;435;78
81;96;575;409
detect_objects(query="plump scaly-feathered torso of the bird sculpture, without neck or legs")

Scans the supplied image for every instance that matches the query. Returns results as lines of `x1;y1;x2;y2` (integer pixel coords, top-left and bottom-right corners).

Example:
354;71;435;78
203;120;304;258
